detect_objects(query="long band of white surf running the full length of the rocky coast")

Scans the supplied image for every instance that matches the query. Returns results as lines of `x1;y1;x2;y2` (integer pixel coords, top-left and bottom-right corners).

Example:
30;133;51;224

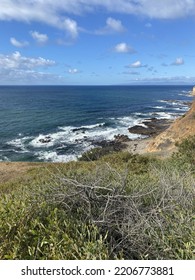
4;100;188;162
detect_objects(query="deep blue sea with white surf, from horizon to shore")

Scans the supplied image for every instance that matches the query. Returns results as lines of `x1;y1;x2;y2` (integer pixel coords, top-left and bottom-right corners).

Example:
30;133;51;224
0;86;192;162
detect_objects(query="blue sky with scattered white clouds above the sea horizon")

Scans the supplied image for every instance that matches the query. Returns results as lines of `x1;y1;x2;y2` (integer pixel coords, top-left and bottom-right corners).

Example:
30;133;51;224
0;0;195;85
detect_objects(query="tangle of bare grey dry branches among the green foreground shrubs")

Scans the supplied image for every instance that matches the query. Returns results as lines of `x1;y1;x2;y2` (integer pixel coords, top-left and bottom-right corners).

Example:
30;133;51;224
38;164;195;258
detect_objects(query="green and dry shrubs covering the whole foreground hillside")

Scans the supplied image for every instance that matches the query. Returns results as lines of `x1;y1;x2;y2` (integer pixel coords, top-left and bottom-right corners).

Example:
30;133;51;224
0;137;195;260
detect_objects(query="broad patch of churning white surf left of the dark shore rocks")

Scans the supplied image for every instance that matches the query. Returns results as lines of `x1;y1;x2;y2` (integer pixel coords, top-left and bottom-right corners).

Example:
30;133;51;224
6;115;144;162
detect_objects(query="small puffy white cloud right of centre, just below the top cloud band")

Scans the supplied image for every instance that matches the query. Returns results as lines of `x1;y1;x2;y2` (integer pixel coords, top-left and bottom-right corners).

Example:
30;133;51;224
95;17;125;35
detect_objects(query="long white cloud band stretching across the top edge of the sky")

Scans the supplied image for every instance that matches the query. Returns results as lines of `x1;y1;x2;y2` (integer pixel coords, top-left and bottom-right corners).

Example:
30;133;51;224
0;0;195;23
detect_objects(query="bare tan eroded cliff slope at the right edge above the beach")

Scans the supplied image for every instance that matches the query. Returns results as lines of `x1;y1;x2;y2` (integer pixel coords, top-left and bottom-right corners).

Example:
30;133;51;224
146;101;195;152
